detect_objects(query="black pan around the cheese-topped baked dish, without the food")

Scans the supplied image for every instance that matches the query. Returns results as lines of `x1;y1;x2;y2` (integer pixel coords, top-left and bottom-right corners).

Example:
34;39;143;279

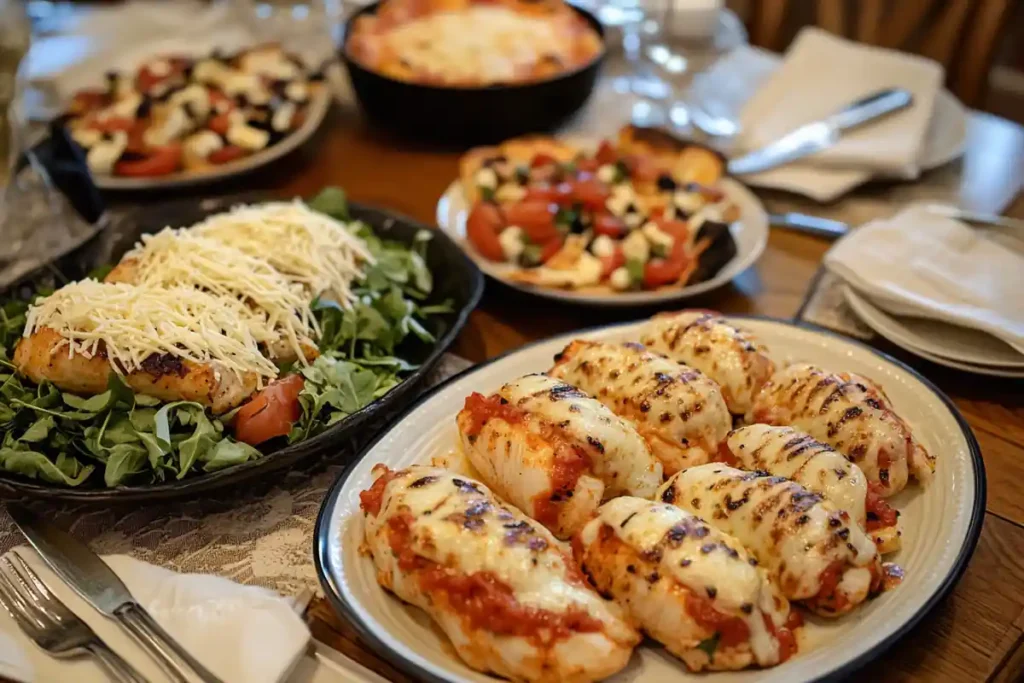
340;2;604;145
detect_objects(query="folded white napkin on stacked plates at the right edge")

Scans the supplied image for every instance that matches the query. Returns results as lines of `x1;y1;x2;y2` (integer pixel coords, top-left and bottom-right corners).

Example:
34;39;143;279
825;206;1024;353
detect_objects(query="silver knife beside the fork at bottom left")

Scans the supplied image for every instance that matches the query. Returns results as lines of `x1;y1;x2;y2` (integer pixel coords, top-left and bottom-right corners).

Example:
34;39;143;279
6;503;222;683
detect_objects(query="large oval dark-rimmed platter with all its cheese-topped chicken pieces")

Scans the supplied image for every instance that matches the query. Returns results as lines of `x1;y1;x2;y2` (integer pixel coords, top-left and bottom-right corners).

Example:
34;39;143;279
314;310;985;683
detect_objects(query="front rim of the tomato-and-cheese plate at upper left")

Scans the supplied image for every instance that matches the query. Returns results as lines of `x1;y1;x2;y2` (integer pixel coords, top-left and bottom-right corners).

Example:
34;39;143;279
92;87;334;191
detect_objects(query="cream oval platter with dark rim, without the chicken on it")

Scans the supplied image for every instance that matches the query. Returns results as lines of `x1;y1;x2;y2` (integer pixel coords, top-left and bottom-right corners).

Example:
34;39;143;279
314;318;985;683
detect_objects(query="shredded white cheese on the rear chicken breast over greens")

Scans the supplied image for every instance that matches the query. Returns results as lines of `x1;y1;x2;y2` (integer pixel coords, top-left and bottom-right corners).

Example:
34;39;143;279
190;200;374;308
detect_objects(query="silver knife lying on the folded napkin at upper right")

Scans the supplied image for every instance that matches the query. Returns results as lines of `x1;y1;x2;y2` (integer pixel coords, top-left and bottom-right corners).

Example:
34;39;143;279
728;88;913;175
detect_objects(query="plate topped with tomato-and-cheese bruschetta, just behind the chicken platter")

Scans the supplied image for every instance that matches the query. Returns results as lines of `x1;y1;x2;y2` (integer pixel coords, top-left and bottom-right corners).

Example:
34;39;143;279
437;125;768;305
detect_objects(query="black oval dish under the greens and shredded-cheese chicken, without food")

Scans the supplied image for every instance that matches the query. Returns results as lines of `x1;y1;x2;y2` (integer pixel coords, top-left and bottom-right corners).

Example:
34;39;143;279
0;193;483;504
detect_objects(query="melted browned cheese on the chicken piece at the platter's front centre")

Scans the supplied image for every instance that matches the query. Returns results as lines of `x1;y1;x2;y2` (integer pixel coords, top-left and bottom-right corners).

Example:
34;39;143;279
580;497;788;665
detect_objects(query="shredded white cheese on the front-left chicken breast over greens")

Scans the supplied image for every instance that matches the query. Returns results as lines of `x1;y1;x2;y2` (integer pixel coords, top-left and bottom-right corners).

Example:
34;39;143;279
25;280;278;378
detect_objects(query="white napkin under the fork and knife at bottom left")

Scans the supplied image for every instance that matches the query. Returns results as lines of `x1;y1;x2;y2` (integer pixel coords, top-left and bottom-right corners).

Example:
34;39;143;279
0;547;309;683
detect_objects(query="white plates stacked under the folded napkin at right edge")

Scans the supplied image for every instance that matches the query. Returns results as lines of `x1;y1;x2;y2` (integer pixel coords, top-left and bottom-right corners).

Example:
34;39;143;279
843;287;1024;377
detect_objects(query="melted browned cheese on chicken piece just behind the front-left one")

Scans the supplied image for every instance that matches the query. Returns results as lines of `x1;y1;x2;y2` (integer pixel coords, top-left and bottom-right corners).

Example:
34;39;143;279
498;375;663;498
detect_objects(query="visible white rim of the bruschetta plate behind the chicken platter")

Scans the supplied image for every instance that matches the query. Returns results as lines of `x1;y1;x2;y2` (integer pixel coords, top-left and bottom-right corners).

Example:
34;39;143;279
437;178;768;306
